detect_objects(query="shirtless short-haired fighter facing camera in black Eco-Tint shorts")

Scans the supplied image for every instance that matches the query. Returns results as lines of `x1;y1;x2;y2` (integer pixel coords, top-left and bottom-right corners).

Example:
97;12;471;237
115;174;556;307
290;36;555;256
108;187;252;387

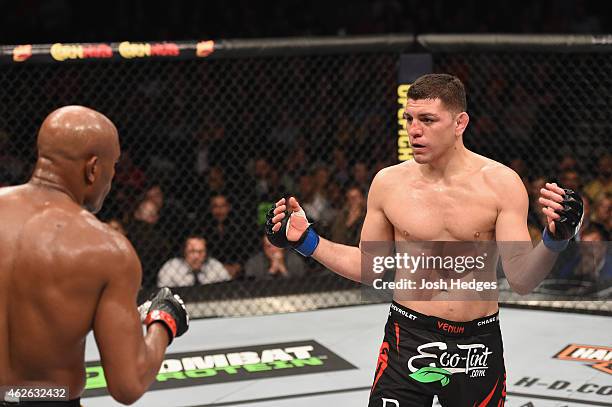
266;74;582;407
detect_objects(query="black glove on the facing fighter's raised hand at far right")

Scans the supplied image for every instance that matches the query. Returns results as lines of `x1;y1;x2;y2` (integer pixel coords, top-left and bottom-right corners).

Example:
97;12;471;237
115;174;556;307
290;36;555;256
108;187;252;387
542;188;584;252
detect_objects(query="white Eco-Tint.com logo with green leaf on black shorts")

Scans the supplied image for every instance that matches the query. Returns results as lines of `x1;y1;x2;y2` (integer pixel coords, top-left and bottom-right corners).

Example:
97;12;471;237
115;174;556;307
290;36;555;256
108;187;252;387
408;342;493;387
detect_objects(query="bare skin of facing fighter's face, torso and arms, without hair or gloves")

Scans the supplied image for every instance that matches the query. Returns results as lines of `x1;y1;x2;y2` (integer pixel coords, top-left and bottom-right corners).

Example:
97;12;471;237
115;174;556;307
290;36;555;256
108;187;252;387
273;99;563;321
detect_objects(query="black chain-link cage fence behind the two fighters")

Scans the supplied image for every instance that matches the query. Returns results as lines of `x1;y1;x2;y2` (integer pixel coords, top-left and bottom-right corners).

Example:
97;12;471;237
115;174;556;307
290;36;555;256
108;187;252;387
0;36;612;317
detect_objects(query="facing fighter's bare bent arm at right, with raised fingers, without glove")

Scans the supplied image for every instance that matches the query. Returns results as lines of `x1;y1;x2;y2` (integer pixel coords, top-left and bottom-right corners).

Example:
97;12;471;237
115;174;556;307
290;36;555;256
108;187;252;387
495;169;582;295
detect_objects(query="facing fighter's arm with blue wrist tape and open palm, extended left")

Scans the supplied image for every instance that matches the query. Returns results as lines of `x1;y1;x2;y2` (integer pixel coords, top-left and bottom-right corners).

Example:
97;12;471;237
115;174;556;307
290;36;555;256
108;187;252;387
268;173;393;284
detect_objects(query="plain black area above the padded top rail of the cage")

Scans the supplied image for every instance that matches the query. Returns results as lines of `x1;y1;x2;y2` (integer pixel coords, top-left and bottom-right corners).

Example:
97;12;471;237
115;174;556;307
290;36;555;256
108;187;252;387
0;0;612;43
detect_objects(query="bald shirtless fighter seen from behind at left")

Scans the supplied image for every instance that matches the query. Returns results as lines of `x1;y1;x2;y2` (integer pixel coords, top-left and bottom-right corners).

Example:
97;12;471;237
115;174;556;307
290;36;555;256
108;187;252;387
0;106;189;406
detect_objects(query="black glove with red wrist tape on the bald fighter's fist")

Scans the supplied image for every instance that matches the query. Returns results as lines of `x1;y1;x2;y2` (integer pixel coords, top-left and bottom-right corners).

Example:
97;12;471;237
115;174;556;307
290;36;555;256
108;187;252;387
139;287;189;345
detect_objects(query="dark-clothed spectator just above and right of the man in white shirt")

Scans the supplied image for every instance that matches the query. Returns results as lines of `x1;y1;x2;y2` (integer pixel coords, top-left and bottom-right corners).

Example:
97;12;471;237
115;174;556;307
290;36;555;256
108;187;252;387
205;195;254;278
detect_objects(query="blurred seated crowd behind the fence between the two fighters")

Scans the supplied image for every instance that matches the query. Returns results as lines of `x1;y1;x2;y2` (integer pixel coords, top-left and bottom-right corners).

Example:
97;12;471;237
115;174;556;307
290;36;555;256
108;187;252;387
101;147;376;285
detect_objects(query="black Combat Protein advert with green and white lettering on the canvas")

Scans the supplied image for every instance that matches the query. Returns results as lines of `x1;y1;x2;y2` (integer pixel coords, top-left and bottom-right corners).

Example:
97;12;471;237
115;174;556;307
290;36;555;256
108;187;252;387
83;340;356;397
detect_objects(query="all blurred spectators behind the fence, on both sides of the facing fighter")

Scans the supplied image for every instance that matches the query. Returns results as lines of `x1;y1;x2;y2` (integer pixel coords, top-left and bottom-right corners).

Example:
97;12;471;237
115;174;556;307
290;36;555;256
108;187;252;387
0;113;612;286
